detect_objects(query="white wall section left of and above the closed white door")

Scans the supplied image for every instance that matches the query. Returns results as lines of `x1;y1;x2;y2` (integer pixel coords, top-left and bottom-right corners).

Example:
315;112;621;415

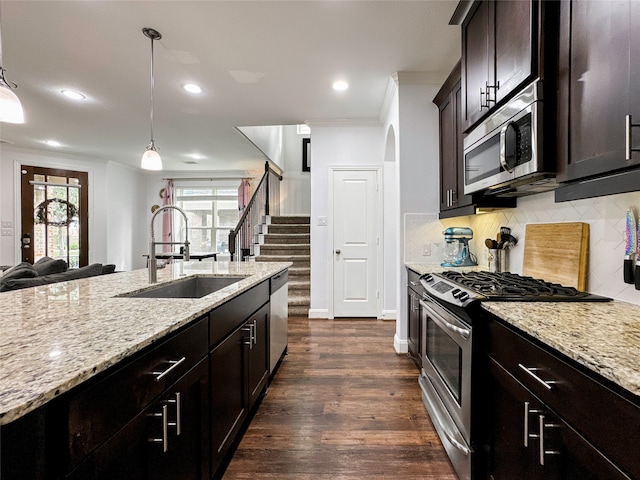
309;124;385;318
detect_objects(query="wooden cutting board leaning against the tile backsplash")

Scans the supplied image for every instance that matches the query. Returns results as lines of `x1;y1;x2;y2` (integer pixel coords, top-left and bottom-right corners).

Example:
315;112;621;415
522;222;589;291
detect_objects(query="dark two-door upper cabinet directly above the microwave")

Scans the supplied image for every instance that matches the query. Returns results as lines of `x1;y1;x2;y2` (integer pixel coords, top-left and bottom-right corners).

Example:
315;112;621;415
451;0;557;131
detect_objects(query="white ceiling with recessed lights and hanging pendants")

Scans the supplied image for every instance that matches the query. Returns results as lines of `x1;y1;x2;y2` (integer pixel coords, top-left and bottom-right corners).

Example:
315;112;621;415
0;0;460;171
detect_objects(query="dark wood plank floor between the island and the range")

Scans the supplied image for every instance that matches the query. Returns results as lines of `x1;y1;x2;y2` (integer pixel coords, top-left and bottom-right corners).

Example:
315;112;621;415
223;317;457;480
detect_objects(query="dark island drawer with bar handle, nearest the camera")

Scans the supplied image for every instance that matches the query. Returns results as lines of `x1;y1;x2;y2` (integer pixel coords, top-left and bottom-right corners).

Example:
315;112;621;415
67;317;208;466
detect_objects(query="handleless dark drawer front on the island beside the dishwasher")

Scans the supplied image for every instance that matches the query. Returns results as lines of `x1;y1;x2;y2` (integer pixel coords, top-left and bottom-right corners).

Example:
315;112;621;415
209;280;269;347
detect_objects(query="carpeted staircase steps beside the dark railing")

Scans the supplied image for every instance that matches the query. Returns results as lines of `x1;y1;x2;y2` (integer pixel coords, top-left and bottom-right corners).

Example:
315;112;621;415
252;216;311;317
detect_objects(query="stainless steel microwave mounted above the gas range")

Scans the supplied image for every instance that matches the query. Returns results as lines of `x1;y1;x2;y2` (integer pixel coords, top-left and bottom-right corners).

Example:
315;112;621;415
464;82;556;196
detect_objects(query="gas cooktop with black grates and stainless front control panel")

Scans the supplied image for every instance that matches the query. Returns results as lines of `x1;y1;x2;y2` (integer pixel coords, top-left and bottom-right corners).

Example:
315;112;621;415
420;270;611;307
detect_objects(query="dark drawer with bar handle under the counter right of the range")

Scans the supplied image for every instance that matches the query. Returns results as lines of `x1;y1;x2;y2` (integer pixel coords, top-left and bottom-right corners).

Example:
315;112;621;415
488;320;640;478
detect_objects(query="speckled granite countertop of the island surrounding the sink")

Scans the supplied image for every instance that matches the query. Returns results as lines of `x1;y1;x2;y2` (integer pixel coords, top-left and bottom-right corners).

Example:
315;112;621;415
0;261;291;425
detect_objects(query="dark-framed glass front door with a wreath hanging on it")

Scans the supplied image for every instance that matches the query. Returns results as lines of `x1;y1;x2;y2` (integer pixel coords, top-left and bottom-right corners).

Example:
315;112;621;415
20;165;89;268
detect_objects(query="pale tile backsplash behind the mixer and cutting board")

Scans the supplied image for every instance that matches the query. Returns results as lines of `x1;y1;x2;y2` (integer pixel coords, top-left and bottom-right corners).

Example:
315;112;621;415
404;192;640;304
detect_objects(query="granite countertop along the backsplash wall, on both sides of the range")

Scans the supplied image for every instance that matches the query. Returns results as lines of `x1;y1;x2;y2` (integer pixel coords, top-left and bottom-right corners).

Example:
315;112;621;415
406;263;640;396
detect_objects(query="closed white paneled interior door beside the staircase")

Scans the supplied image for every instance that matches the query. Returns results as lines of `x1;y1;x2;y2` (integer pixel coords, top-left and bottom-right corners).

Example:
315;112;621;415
331;169;380;317
